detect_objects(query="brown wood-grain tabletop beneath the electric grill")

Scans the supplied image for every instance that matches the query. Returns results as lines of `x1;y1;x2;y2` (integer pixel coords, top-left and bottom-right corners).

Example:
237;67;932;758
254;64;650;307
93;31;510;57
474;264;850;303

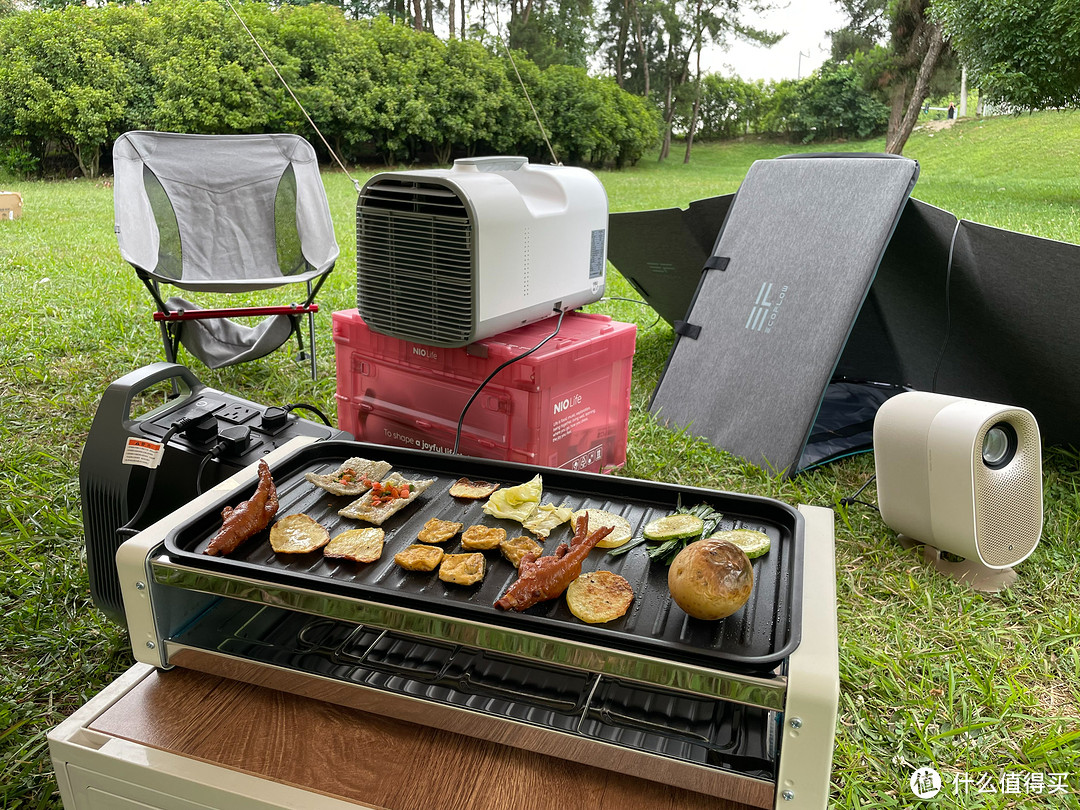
91;669;760;810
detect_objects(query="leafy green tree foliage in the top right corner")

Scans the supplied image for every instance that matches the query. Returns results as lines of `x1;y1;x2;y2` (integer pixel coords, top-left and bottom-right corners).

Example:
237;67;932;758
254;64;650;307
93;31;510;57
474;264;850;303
934;0;1080;110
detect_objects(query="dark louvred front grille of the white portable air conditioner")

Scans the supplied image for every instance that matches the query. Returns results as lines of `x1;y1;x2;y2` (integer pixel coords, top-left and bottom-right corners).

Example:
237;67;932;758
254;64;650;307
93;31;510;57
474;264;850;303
356;178;475;345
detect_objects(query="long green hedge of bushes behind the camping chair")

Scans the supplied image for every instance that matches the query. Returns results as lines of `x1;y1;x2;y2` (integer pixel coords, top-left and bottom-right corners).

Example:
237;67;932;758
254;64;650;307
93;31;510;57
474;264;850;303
0;0;660;176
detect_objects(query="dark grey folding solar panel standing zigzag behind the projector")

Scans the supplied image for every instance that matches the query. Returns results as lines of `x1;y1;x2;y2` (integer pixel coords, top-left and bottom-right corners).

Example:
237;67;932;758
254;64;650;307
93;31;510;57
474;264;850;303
608;154;1080;474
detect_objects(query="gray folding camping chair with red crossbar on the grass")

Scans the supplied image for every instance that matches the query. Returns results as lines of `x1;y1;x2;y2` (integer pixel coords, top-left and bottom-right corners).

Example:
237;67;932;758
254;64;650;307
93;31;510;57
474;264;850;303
112;132;338;379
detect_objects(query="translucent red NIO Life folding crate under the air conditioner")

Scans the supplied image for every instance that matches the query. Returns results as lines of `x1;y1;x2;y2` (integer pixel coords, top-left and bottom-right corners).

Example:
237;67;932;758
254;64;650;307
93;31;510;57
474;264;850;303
333;309;637;472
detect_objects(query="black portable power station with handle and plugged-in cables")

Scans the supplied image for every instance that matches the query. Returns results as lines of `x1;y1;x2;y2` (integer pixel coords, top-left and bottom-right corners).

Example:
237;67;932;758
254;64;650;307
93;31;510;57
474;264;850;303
79;363;352;624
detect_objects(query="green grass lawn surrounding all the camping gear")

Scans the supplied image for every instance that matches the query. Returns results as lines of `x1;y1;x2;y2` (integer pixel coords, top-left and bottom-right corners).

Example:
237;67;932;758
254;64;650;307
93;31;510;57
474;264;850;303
6;112;1080;810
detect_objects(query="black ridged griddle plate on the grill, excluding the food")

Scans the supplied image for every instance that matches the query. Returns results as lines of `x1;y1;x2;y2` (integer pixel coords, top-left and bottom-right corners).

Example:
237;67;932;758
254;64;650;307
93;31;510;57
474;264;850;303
159;442;802;672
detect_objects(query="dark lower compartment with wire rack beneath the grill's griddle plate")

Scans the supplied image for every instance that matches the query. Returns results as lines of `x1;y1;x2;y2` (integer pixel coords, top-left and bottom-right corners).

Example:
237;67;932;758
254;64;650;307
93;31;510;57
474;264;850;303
172;599;780;781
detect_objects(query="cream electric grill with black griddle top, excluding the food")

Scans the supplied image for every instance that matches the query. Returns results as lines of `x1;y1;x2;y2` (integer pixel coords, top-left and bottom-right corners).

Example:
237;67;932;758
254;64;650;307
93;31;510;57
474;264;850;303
117;438;838;807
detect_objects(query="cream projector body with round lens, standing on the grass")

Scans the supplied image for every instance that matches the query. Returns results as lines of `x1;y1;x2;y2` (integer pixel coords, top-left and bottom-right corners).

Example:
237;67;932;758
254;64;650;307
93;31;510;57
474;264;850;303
874;391;1042;587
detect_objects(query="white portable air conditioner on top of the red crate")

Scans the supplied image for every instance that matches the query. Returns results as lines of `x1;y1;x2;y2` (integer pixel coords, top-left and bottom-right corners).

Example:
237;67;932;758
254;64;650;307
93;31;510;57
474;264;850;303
356;157;608;347
